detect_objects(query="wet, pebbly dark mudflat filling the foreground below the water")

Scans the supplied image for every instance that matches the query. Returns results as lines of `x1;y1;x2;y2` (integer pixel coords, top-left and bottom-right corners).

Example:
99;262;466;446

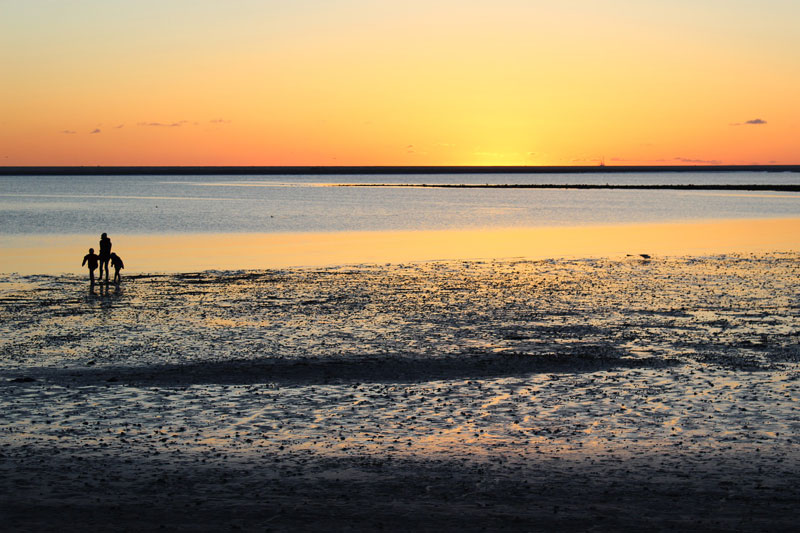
0;253;800;531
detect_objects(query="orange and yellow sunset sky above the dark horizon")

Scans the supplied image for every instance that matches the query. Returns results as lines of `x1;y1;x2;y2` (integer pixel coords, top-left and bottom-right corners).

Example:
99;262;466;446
0;0;800;165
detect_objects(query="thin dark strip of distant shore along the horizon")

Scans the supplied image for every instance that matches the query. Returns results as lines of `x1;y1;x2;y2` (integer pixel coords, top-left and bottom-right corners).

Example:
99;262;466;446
0;165;800;176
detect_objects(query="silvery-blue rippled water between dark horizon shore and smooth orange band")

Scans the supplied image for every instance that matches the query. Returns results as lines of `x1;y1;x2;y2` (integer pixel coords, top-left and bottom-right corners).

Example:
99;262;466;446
0;172;800;236
